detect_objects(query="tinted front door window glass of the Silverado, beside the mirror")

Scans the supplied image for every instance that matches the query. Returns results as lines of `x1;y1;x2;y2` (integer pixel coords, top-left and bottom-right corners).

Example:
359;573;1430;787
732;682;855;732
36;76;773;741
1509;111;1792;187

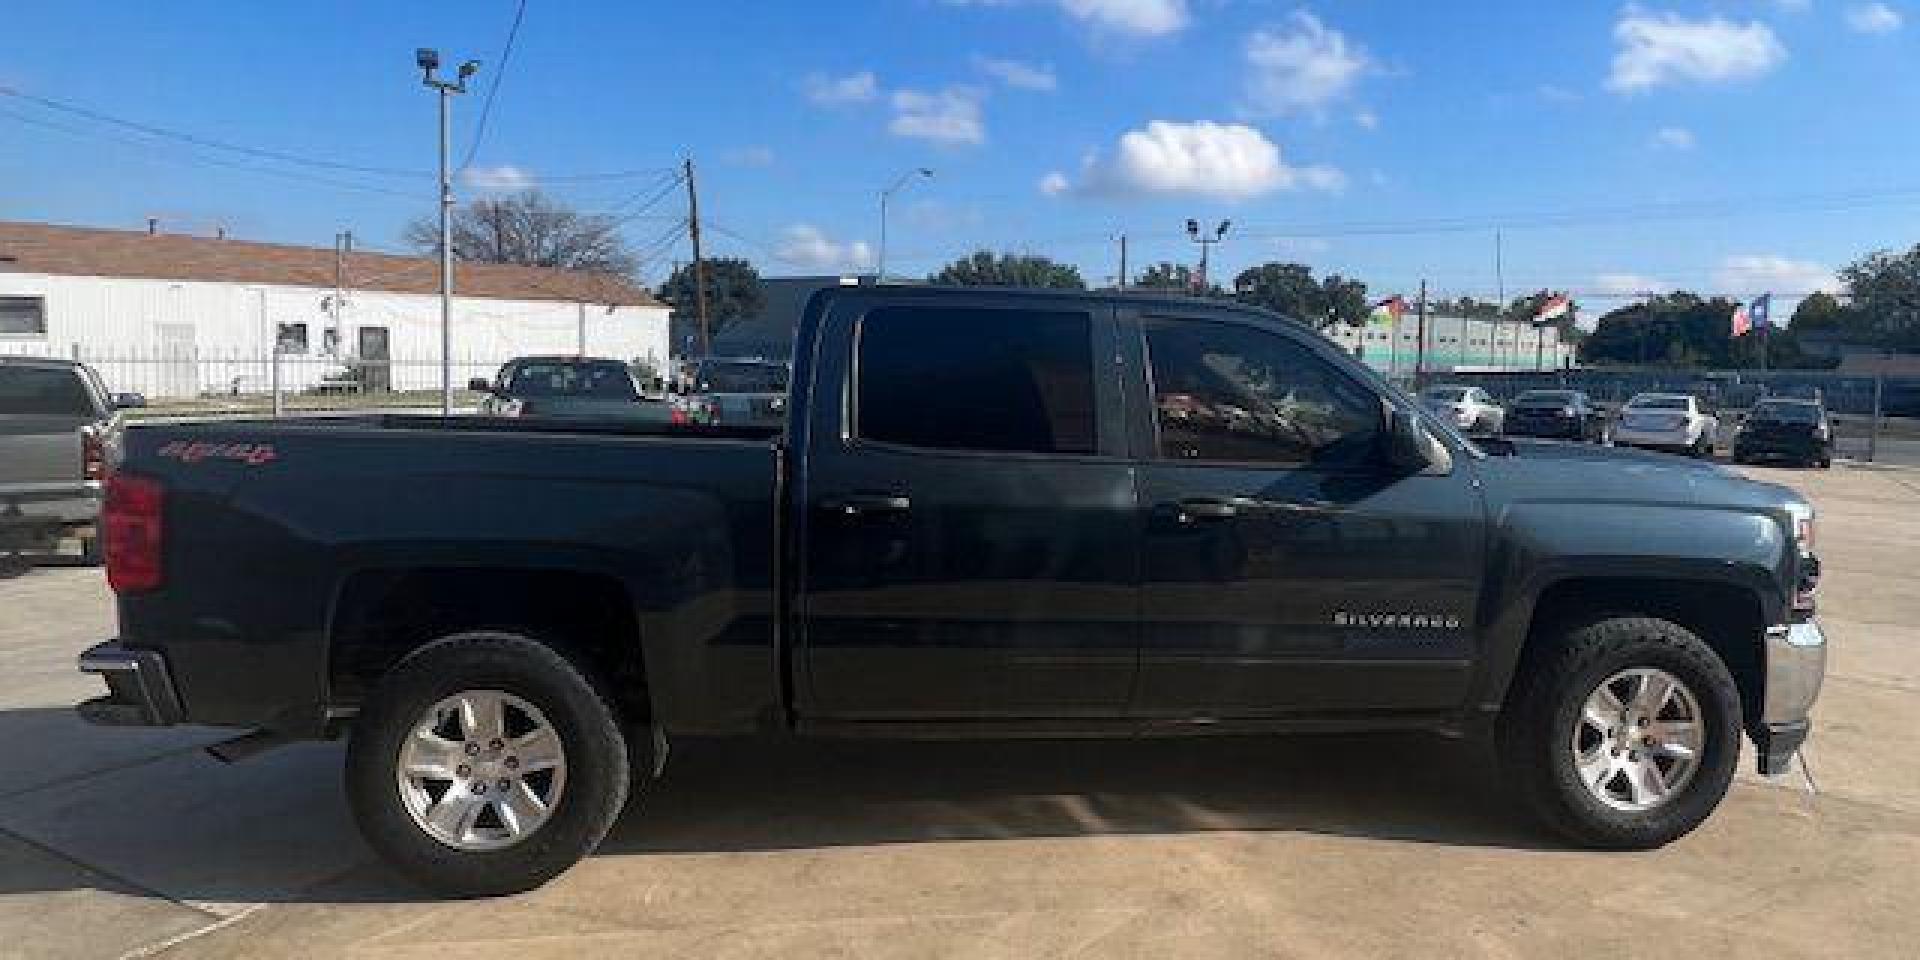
1146;319;1380;467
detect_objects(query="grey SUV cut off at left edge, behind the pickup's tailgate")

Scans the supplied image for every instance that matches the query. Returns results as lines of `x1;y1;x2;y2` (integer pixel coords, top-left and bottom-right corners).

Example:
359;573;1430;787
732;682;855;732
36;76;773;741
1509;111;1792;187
0;357;146;561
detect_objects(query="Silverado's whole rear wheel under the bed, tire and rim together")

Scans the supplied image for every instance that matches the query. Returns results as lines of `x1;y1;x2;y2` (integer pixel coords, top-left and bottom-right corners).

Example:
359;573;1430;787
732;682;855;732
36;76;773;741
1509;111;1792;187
348;632;628;897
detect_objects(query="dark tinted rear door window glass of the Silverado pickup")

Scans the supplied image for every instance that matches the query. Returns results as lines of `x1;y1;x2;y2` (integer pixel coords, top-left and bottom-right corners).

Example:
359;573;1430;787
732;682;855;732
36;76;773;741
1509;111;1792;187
854;307;1096;453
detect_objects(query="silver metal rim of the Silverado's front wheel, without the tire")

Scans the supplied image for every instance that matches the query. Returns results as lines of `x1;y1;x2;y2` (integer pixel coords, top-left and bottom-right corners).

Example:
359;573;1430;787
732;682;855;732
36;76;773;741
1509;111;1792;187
1572;666;1707;812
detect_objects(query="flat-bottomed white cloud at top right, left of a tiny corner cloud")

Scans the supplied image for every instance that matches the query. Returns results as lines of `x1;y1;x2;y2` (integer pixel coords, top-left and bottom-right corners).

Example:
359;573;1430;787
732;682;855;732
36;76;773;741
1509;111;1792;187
1607;6;1788;92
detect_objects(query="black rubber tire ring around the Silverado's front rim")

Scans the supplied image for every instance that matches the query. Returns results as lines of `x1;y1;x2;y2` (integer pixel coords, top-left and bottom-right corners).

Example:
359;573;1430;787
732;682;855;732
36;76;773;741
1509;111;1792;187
1498;616;1741;851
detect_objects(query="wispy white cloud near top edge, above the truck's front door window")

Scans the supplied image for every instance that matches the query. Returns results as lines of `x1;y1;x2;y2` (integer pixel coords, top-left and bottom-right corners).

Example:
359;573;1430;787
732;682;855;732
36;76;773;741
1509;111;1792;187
1246;10;1379;115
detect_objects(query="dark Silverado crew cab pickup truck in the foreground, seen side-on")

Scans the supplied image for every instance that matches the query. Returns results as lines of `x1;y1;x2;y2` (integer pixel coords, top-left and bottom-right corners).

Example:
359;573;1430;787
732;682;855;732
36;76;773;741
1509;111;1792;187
81;286;1826;895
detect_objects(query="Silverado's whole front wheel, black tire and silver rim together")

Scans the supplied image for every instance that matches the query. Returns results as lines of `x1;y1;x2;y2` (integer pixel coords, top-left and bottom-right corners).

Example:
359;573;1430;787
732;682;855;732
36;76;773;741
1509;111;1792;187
1500;616;1740;851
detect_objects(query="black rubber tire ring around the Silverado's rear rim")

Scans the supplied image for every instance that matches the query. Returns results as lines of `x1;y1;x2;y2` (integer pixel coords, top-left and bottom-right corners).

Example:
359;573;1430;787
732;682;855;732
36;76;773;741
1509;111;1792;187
346;632;628;897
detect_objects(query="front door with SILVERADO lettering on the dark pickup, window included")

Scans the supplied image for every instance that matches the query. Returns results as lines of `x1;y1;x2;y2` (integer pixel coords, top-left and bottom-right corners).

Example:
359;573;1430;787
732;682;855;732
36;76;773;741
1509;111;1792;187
1137;315;1482;720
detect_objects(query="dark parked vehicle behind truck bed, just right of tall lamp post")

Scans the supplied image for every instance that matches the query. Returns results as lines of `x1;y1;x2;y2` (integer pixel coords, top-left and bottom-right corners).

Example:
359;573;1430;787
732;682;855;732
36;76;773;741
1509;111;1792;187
467;357;672;422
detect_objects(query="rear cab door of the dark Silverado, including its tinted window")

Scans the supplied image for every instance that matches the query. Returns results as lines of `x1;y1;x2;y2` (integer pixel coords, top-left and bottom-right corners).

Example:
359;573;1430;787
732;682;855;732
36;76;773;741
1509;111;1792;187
793;290;1139;722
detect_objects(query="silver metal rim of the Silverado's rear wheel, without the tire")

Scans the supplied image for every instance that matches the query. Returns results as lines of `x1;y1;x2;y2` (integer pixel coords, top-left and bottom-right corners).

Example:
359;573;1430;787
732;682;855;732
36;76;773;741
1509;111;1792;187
396;689;566;851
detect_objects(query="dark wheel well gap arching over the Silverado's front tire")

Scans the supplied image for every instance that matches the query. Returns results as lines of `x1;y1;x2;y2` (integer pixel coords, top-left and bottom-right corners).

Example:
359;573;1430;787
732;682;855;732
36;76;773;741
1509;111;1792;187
1509;578;1766;720
